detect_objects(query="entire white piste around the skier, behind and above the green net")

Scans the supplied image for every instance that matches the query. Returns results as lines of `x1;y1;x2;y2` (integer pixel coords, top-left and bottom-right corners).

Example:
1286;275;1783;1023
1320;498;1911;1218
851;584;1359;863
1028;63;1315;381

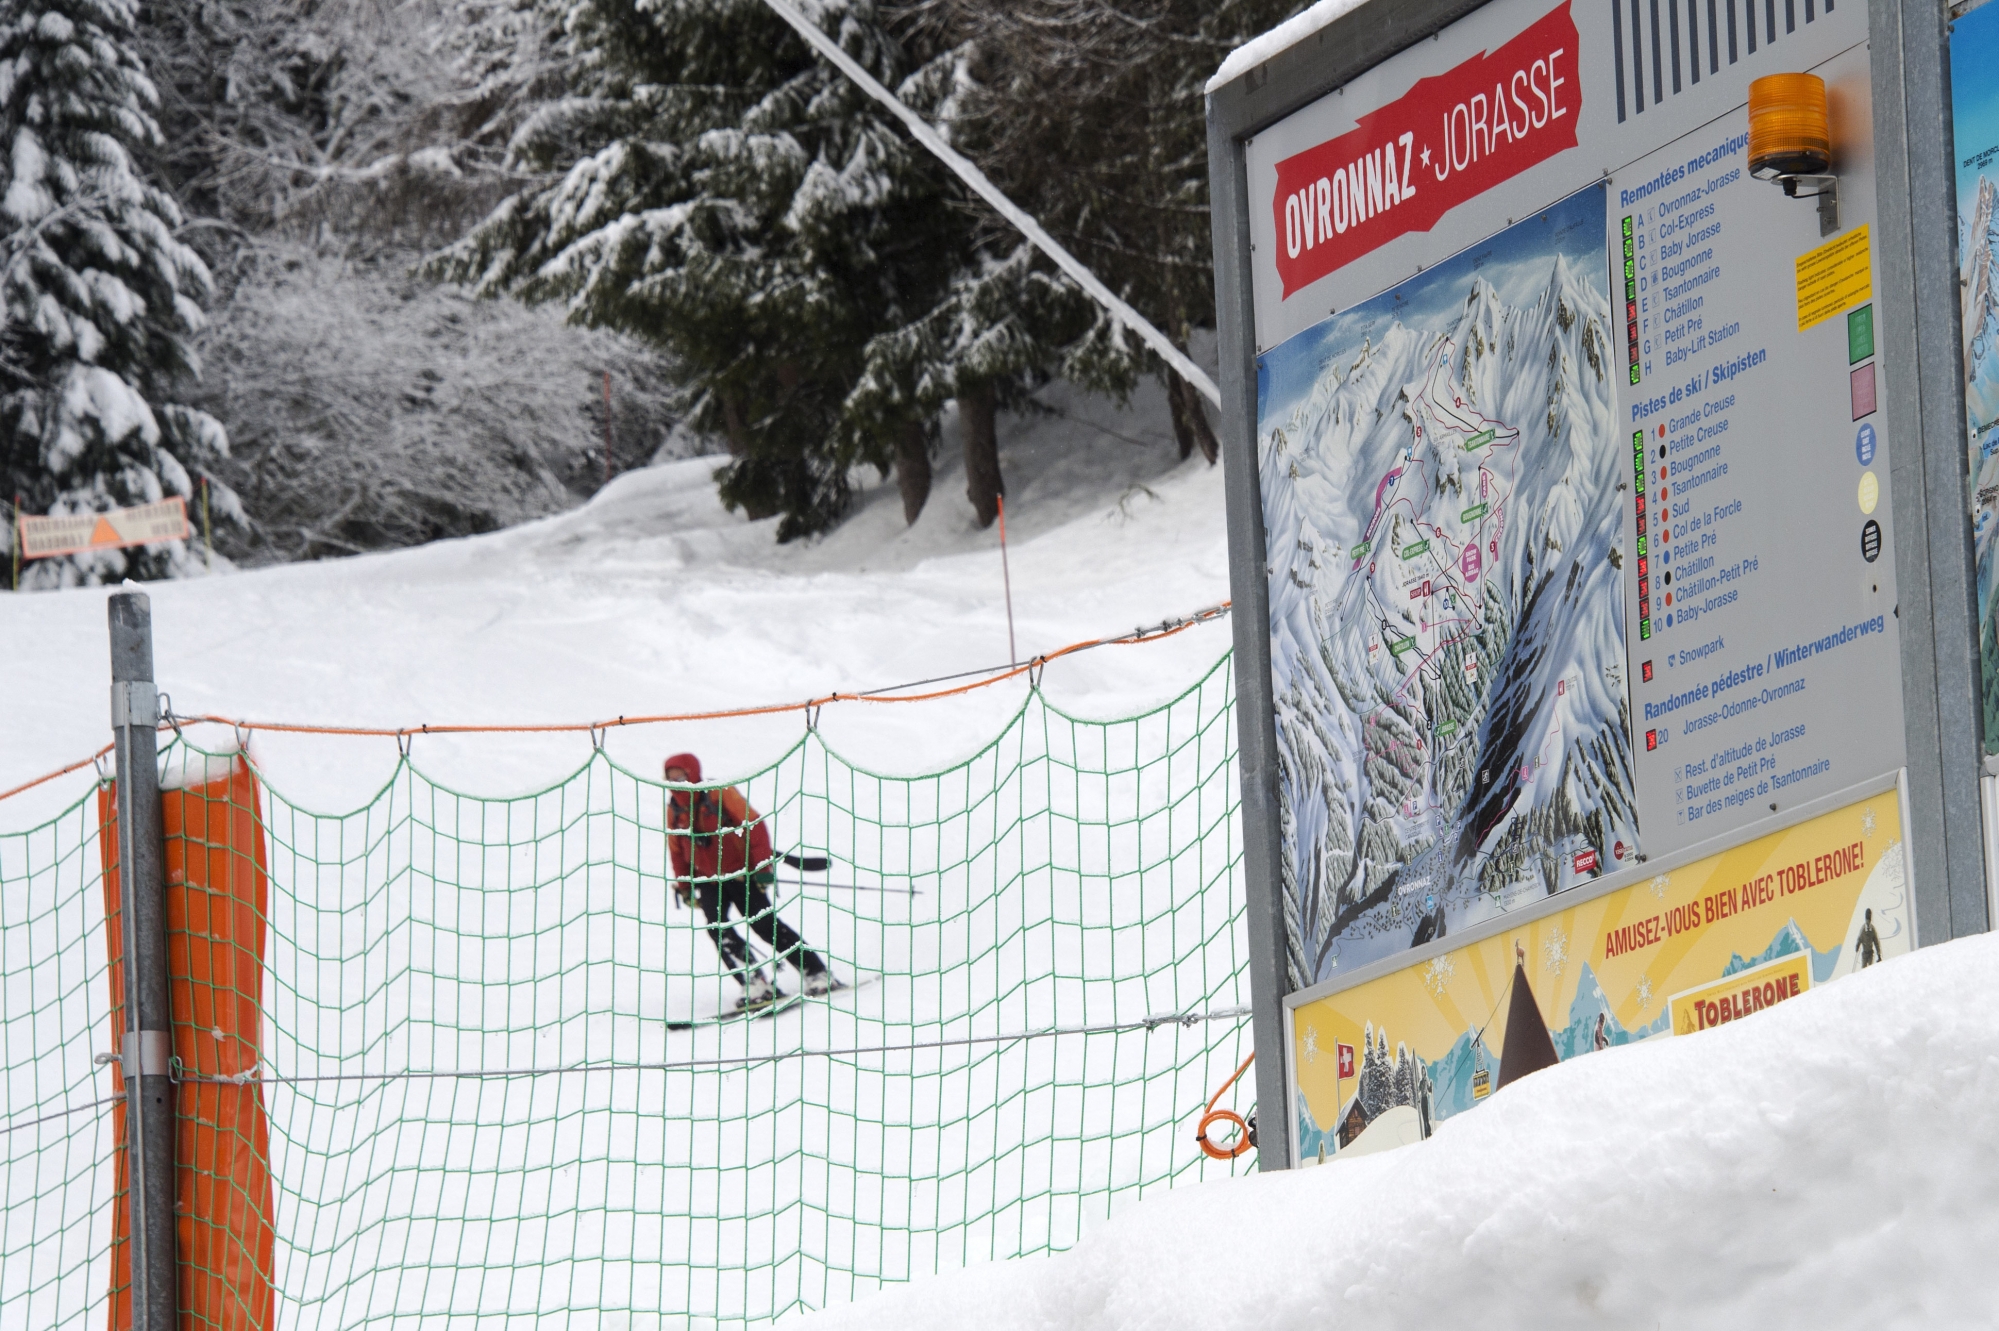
0;367;1247;1325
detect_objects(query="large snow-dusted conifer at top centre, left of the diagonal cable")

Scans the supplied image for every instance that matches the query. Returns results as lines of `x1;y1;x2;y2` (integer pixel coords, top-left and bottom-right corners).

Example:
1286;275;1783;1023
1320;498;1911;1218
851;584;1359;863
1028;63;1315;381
432;0;968;540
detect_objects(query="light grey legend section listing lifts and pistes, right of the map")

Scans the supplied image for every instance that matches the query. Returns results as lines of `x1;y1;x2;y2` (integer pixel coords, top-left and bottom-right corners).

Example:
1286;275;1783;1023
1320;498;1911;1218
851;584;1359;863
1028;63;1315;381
1607;95;1903;855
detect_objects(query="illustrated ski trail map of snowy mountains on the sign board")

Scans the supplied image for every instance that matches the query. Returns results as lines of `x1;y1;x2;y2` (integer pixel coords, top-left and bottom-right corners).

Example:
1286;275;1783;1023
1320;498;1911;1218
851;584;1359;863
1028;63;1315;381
1257;186;1639;987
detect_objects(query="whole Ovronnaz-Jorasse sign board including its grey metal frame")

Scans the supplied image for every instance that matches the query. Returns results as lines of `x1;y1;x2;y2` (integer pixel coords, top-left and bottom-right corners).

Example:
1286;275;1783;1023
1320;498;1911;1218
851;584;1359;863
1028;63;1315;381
1209;0;1999;1161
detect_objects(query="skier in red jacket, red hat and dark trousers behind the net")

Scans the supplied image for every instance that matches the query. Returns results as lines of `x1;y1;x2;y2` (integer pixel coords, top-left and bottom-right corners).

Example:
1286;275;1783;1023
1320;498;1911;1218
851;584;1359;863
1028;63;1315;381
666;753;840;1007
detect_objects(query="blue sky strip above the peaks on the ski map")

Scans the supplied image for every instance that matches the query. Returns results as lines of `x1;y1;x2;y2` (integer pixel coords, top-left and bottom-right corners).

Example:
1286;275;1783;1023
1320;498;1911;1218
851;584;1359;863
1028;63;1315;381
1255;182;1615;430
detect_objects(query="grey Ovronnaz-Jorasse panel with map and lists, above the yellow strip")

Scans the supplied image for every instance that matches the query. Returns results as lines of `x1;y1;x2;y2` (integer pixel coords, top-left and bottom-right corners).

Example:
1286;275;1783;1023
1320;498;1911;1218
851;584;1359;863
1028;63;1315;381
1243;0;1903;987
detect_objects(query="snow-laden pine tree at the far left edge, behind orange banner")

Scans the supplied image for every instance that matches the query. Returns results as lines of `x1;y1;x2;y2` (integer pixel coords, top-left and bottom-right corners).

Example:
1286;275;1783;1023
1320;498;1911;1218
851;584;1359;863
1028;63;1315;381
0;0;240;586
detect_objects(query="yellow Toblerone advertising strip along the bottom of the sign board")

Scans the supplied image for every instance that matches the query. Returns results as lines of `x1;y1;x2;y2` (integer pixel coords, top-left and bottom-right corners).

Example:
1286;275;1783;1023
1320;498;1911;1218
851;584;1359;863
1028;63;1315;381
1291;789;1913;1163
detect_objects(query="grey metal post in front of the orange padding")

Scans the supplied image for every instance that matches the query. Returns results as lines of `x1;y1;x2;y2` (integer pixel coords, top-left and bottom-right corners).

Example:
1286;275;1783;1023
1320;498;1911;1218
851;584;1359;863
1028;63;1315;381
110;592;178;1331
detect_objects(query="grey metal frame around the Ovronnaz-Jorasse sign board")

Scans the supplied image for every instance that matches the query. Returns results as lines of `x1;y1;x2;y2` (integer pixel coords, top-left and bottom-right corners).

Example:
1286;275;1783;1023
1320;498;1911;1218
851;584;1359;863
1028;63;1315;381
1207;0;1989;1169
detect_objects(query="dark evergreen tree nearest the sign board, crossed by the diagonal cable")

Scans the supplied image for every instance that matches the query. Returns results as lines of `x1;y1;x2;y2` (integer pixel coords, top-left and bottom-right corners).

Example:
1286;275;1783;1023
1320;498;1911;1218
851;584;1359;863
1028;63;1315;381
884;0;1301;462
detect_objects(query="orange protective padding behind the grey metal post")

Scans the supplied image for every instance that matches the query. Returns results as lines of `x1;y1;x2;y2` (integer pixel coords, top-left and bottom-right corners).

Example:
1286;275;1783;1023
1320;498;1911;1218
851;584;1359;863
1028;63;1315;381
98;759;276;1331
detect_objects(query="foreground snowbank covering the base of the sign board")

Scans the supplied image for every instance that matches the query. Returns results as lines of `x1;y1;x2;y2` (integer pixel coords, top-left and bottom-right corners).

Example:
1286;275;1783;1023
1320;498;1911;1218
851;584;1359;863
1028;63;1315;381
794;937;1999;1331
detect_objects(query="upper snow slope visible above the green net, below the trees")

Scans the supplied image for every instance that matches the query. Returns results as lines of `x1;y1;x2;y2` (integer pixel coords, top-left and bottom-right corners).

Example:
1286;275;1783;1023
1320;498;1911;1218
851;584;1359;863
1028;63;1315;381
0;373;1229;827
